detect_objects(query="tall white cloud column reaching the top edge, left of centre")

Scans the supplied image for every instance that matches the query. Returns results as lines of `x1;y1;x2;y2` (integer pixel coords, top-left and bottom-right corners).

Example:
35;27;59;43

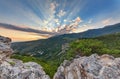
43;1;60;30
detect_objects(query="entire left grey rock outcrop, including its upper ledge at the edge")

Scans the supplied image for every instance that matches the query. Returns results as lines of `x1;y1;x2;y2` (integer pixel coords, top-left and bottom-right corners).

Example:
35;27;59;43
0;36;50;79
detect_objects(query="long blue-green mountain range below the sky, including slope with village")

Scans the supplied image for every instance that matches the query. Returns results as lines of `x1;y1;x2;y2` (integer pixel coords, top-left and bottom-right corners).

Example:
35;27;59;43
12;23;120;59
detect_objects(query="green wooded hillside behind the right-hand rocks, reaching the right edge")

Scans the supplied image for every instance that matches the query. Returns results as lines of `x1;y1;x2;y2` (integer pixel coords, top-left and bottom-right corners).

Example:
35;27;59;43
64;33;120;59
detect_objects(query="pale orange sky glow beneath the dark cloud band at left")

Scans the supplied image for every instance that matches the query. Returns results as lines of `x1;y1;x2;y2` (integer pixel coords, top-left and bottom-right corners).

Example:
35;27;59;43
0;28;48;42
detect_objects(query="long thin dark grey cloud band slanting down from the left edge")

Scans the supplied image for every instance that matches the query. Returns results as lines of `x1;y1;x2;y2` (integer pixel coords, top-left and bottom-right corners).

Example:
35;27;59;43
0;23;55;35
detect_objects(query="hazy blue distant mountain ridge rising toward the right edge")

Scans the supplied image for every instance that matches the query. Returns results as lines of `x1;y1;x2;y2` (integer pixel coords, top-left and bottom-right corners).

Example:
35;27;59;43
53;23;120;38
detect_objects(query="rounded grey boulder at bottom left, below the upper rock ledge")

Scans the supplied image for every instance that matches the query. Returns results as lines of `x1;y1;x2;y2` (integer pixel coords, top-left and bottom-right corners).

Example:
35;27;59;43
0;59;50;79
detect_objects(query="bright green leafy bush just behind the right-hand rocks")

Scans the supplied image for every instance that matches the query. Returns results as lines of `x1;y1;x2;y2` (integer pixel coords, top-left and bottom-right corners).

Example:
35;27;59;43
66;39;106;59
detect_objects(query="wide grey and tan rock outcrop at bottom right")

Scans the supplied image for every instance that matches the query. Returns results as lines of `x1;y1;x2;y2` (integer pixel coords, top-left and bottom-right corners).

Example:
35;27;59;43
54;54;120;79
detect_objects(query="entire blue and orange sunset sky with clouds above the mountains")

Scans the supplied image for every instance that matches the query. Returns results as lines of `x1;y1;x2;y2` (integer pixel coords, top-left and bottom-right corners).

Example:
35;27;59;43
0;0;120;42
